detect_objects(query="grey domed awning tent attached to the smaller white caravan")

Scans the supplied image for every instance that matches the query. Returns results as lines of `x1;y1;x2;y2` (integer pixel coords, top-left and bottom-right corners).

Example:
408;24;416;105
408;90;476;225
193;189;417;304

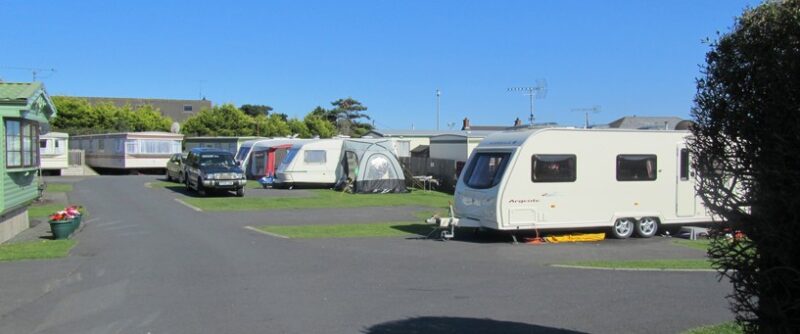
337;139;408;193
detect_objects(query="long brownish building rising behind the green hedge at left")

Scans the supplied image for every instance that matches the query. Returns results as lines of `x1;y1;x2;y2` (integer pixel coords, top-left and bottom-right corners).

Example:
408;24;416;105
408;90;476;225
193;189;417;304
66;96;211;123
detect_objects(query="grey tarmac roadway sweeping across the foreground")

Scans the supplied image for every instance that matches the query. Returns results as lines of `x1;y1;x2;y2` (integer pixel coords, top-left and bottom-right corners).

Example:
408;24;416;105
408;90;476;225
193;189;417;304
0;176;733;334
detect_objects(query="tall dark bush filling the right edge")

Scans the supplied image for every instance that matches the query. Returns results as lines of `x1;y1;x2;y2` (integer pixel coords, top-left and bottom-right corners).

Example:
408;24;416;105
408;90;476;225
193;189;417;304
691;0;800;333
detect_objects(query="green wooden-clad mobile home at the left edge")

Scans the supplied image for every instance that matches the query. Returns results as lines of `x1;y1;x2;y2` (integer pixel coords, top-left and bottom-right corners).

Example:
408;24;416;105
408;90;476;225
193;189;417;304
0;82;56;242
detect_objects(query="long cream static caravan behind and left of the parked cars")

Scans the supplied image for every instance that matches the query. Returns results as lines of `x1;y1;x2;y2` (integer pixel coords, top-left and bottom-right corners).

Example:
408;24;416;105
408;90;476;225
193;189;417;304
70;132;183;169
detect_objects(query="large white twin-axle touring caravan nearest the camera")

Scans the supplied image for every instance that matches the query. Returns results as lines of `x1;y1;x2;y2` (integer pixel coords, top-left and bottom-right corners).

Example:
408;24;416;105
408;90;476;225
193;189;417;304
444;128;712;238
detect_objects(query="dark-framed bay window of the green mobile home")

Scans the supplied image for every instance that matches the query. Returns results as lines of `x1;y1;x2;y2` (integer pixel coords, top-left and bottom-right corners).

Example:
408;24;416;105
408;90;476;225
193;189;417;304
5;119;39;168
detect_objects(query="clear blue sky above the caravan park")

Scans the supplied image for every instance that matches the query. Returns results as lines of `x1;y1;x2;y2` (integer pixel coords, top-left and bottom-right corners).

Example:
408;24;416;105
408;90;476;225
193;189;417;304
0;0;759;129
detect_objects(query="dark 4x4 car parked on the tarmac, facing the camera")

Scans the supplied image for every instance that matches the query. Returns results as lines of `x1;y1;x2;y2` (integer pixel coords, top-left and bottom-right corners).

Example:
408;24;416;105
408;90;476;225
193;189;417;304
184;148;247;197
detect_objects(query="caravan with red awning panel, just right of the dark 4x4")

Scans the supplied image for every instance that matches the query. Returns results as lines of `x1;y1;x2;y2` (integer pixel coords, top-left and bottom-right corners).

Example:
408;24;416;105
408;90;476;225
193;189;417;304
236;138;313;179
